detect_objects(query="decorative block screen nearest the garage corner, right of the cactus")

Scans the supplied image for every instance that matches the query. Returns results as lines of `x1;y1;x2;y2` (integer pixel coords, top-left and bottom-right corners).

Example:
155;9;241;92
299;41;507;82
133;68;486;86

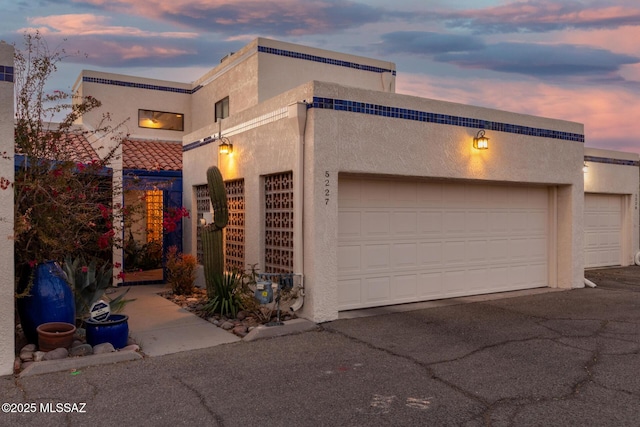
264;172;293;273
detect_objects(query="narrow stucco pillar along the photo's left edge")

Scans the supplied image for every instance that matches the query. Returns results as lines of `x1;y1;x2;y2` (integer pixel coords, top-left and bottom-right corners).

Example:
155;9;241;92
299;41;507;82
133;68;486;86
0;41;15;375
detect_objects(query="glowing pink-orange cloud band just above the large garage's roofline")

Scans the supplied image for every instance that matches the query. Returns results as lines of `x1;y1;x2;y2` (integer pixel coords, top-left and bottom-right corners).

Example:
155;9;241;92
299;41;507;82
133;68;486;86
397;74;640;153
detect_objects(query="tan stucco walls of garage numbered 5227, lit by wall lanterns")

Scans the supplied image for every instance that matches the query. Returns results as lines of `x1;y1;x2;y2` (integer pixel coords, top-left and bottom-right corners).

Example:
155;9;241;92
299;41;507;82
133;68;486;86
183;82;584;322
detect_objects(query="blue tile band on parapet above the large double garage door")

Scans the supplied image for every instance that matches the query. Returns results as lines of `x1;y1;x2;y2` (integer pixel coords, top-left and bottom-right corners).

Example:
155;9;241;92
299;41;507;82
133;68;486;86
307;96;584;143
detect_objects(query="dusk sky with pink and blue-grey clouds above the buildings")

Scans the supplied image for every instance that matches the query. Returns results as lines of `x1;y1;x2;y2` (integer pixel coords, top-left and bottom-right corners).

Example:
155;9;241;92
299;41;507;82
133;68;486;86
0;0;640;153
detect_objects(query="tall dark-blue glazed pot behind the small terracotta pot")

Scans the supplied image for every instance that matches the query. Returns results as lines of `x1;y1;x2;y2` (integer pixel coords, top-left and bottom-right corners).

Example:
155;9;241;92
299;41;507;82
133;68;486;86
16;261;76;344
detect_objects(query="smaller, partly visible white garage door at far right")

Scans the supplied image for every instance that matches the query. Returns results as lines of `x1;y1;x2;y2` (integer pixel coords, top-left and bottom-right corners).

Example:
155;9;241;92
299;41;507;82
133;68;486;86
584;193;622;267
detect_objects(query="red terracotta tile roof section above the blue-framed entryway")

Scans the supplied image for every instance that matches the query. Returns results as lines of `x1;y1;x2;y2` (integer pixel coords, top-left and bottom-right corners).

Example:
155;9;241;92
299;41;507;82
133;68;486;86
122;139;182;171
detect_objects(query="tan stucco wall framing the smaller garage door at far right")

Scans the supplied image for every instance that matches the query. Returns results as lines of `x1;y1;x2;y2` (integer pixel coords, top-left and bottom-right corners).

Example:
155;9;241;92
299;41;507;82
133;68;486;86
583;148;640;265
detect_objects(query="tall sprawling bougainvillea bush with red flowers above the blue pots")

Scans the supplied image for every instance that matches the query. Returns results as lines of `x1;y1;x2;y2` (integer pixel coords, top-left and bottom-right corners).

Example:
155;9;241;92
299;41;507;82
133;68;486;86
10;33;126;290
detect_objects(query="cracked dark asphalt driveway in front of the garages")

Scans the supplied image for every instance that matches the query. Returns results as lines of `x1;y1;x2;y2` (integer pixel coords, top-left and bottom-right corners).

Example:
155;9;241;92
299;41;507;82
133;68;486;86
0;267;640;426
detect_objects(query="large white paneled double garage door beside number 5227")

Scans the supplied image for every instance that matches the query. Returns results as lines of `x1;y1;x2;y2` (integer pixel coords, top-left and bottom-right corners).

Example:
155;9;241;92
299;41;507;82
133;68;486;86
338;177;549;310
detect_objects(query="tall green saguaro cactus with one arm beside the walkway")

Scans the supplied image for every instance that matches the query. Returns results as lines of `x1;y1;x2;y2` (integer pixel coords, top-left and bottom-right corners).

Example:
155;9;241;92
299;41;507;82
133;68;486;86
201;166;229;298
